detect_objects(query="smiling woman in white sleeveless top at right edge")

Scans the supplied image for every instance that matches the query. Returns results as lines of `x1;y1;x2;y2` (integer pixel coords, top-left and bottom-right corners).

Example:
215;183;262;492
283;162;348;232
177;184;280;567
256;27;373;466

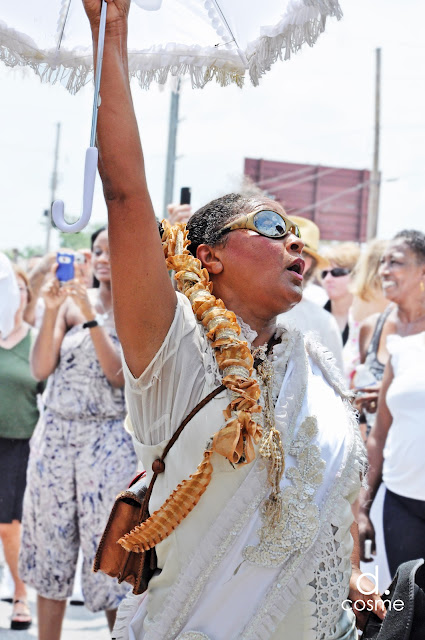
359;230;425;587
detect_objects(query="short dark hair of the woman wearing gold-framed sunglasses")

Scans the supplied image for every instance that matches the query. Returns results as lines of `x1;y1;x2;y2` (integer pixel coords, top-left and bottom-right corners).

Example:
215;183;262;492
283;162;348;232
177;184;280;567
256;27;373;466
187;193;283;257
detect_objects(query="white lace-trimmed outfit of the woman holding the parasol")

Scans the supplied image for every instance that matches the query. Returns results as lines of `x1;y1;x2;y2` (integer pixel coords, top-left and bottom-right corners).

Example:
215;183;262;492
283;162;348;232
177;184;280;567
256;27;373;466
119;294;359;640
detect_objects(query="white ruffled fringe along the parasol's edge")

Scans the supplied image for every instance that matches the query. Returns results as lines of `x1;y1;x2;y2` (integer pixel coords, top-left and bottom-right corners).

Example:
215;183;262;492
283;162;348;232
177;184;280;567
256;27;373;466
0;0;342;94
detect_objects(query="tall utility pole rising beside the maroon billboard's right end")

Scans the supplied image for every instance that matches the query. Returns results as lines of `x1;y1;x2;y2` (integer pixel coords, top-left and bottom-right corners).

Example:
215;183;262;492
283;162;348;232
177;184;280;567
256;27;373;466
367;49;381;240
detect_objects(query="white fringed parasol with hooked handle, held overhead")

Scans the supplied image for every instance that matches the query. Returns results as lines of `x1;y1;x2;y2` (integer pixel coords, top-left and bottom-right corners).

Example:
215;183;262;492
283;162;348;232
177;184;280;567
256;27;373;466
0;0;341;231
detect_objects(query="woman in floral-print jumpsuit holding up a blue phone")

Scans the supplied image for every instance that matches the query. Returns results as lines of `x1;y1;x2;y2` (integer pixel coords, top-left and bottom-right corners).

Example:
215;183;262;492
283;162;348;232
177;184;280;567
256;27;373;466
20;227;136;640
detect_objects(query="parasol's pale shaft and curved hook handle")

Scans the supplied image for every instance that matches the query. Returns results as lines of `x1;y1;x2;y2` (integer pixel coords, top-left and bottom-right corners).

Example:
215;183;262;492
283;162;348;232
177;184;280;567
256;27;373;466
52;0;108;233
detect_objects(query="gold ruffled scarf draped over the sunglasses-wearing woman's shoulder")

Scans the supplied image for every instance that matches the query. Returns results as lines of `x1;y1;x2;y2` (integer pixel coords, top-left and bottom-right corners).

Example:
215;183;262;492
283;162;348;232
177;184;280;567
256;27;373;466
118;221;283;552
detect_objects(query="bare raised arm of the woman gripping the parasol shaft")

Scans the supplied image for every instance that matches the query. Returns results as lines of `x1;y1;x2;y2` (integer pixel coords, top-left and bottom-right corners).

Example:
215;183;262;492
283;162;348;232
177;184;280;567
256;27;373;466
83;0;176;377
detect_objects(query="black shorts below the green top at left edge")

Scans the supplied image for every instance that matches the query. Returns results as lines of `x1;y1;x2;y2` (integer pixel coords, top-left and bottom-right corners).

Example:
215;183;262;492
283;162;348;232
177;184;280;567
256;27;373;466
0;438;30;524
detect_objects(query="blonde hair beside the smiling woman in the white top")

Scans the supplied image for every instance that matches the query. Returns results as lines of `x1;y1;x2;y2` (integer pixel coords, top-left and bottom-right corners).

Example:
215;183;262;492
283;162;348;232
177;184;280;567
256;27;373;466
350;240;388;302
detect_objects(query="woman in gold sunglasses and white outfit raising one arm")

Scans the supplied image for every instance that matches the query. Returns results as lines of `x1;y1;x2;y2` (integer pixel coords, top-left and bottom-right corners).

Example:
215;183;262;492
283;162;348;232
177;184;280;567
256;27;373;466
84;0;384;640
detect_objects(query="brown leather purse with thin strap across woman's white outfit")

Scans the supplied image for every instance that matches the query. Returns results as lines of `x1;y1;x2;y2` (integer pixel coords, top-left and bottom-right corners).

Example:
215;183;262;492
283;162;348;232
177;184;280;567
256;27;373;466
93;384;226;595
